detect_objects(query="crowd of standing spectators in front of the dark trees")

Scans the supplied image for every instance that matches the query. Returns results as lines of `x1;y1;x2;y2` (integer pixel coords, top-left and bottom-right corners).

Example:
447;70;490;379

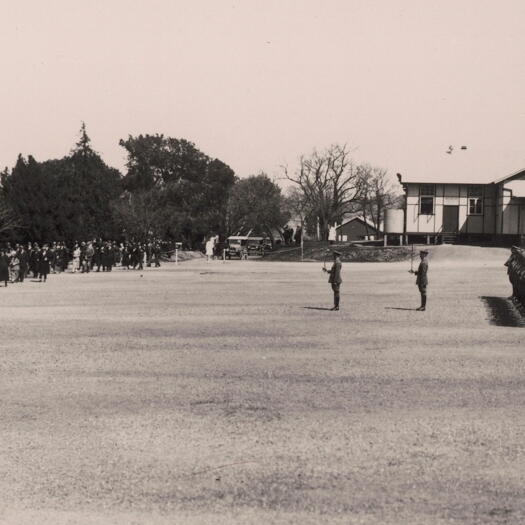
0;240;166;286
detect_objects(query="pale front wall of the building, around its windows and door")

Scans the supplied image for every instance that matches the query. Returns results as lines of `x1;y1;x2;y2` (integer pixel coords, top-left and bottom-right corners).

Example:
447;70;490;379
406;183;496;234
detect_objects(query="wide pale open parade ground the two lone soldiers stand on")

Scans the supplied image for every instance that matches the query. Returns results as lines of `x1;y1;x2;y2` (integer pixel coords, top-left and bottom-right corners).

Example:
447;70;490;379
0;246;525;525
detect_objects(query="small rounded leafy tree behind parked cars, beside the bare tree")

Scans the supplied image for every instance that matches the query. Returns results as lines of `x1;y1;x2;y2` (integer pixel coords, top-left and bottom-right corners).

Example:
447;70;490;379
228;173;290;240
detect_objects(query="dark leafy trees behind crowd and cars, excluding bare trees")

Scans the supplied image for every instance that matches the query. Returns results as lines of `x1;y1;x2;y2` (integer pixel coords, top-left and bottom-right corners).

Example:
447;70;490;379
0;125;290;247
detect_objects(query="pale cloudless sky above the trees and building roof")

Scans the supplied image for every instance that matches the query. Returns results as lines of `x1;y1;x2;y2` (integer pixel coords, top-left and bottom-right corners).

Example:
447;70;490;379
0;0;525;182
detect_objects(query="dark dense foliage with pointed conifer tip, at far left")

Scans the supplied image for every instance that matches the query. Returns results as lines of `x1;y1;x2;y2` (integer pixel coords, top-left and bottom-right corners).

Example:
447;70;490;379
2;125;121;242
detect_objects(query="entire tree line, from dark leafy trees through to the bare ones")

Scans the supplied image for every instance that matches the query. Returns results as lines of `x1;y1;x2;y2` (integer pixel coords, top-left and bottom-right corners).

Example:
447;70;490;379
0;124;395;247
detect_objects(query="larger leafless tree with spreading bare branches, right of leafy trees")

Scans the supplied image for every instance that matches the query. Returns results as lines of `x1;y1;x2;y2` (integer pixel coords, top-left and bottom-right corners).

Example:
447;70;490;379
284;144;361;239
